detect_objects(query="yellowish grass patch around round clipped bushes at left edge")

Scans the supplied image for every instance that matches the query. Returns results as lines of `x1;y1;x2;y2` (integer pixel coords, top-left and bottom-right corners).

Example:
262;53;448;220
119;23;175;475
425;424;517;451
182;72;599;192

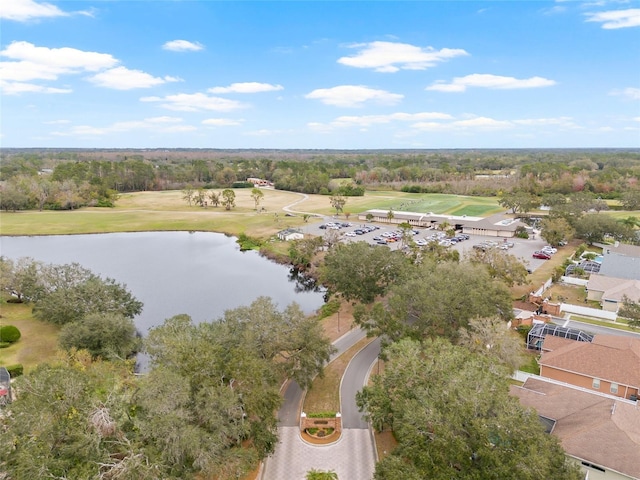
0;302;60;373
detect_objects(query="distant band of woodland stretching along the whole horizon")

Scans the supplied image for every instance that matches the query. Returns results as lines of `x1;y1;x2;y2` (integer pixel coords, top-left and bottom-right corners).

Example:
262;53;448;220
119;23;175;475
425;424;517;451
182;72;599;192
0;149;640;210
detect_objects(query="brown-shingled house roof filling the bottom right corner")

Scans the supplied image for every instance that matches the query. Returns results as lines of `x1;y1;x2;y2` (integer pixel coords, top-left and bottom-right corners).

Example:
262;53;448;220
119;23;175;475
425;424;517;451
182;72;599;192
510;376;640;480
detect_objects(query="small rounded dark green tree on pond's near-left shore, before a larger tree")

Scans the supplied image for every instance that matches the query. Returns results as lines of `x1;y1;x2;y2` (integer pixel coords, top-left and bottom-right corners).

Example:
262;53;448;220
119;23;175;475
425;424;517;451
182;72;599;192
58;313;141;360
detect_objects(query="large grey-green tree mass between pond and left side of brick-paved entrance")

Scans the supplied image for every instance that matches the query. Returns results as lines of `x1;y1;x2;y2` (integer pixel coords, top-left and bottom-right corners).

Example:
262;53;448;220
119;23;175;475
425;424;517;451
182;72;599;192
142;297;333;478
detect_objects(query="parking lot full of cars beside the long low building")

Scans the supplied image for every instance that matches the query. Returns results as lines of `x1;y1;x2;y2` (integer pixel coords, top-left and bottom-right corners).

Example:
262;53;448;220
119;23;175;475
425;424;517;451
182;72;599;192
303;217;547;271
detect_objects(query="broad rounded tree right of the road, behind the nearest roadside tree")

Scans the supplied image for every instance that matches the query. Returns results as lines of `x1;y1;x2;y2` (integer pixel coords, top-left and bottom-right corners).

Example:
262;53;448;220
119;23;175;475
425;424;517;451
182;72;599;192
354;259;513;342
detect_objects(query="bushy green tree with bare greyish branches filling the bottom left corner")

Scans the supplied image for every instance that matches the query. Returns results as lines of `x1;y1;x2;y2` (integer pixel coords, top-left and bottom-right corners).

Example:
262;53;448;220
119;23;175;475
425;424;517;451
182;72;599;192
0;352;155;480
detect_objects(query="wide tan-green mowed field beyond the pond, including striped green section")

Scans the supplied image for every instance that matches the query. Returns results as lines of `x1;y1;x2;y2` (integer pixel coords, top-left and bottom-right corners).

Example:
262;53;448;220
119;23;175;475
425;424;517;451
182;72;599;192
0;189;501;238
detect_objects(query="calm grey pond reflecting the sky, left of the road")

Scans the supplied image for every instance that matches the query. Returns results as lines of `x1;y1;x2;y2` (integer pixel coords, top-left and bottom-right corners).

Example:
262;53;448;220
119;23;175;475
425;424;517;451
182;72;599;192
0;232;323;335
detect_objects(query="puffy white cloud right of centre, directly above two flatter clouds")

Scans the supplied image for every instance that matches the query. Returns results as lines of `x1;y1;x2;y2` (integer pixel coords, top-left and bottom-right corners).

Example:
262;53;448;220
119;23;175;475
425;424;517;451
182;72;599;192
338;42;469;73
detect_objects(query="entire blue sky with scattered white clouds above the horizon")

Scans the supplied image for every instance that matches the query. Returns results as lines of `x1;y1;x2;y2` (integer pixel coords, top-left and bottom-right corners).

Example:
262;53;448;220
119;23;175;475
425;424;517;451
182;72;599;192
0;0;640;149
